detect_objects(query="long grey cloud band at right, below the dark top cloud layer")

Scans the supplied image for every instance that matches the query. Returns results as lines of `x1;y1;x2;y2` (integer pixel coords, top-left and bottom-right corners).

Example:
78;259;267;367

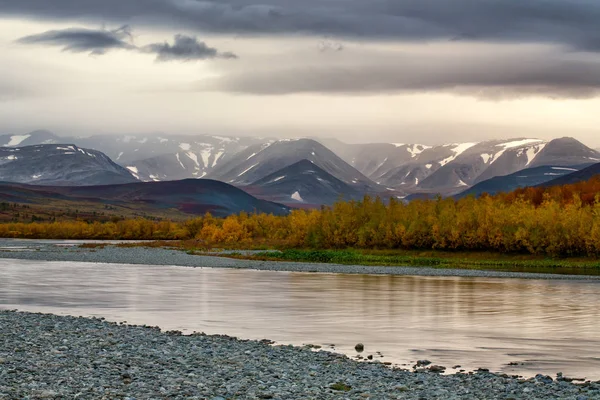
195;51;600;98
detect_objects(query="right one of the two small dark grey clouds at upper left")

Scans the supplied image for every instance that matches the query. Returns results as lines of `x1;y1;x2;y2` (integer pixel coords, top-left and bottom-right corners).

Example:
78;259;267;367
141;35;237;61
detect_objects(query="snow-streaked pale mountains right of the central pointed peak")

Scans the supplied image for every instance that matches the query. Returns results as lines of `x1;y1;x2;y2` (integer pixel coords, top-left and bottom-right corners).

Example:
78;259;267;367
332;138;600;193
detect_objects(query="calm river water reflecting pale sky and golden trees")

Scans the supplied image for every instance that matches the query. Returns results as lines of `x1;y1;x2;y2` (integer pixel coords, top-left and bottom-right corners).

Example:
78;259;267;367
0;260;600;379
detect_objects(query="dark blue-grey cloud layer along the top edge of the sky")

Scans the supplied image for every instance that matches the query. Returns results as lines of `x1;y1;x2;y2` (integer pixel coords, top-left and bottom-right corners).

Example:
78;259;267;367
0;0;600;52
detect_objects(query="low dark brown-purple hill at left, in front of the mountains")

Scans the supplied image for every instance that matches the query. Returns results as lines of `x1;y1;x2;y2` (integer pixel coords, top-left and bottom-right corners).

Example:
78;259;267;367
0;179;289;217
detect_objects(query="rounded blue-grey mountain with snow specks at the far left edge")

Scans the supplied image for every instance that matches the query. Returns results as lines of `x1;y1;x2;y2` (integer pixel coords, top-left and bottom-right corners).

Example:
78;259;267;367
0;144;137;186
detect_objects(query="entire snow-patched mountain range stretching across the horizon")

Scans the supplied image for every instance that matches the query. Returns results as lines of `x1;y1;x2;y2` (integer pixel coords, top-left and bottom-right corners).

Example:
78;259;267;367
0;131;600;206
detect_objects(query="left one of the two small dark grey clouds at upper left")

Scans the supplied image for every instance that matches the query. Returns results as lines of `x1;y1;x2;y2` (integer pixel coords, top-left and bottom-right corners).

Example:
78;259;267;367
17;25;135;55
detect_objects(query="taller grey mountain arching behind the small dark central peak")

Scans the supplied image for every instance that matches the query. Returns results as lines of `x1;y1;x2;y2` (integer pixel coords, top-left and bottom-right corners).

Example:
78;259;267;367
208;139;379;192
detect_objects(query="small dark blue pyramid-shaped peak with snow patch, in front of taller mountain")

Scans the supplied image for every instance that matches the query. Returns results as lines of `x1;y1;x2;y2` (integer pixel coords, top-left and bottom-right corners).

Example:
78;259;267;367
244;160;364;205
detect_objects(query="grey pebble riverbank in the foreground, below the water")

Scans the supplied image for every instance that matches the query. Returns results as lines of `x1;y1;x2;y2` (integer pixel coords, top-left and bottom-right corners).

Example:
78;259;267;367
0;311;600;400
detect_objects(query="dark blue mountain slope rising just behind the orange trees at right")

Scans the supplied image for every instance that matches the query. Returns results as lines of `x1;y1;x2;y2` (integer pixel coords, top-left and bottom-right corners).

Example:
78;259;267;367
455;164;589;198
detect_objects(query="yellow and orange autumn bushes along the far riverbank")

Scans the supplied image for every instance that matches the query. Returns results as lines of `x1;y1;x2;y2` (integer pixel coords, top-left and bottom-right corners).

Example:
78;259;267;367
0;178;600;258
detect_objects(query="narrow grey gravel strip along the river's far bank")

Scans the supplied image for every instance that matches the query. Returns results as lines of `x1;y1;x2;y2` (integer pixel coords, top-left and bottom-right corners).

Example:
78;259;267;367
0;239;600;281
